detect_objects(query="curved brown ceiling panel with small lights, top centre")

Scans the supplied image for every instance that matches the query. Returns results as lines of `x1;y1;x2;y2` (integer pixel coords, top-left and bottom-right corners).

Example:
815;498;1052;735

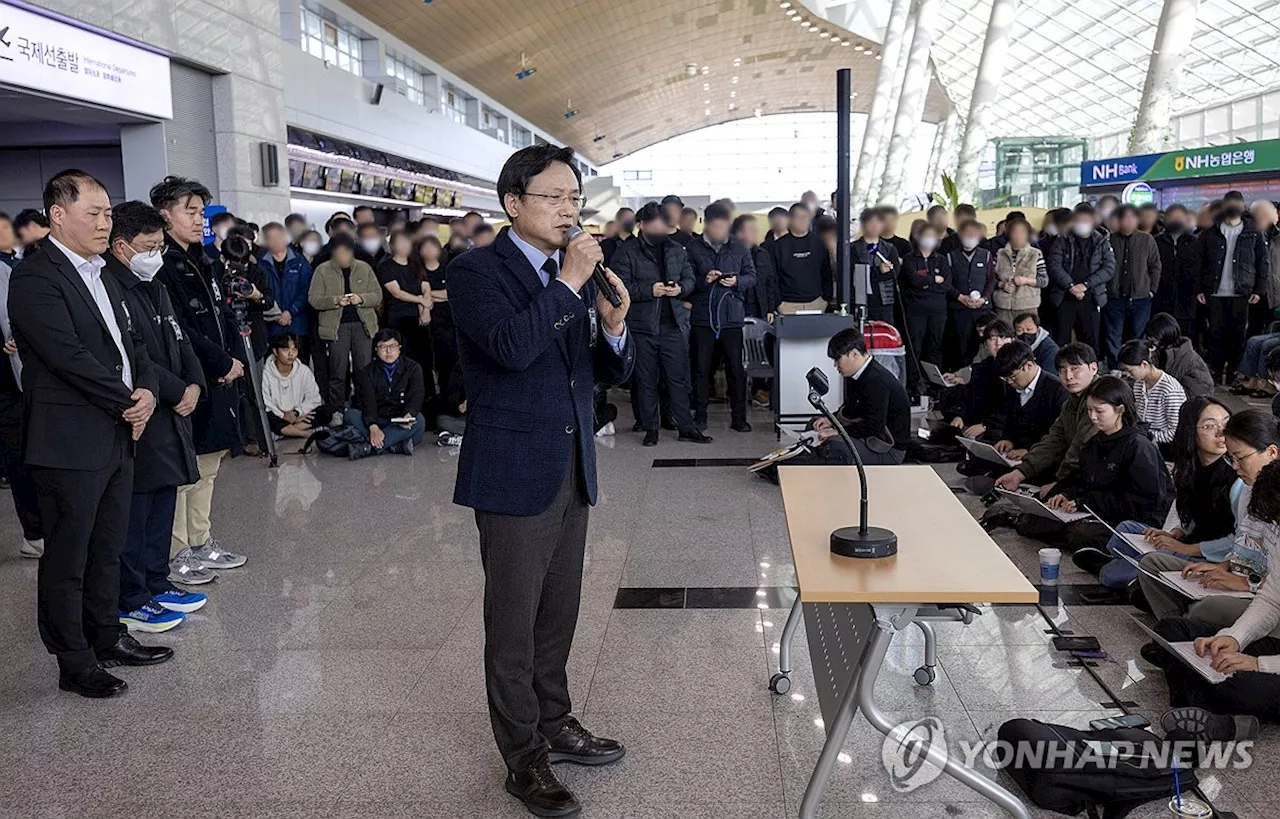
346;0;950;164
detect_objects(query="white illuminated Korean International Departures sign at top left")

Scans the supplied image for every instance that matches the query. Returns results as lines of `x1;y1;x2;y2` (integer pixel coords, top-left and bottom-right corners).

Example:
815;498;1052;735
0;3;173;119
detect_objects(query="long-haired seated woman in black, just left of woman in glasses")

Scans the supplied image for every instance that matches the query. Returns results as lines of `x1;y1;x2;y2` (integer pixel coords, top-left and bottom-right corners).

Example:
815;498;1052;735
1073;397;1244;589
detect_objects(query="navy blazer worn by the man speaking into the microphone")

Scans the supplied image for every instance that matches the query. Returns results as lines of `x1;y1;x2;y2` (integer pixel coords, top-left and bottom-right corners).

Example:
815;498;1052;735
448;228;635;516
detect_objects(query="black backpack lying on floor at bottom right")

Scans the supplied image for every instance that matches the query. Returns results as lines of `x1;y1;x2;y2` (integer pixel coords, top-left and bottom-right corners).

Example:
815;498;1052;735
997;719;1197;819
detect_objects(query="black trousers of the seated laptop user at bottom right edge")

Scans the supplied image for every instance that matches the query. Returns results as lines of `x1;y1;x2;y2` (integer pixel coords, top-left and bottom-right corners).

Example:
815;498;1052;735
1155;617;1280;722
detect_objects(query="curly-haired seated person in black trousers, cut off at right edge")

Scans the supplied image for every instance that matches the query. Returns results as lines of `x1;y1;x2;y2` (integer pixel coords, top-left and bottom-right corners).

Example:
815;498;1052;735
1143;465;1280;738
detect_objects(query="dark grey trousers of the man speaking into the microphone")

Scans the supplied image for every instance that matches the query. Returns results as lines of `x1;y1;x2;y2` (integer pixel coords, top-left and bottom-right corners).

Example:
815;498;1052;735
476;447;590;770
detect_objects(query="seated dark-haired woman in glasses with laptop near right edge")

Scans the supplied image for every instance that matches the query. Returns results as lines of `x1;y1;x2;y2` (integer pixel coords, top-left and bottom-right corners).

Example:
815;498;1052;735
1138;410;1280;626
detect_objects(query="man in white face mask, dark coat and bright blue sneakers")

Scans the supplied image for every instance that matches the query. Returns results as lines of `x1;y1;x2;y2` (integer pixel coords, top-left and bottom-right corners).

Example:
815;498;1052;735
104;202;206;632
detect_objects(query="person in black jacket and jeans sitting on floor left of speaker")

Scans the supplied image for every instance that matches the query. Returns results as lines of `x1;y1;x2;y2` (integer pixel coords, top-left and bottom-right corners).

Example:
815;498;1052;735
344;329;426;461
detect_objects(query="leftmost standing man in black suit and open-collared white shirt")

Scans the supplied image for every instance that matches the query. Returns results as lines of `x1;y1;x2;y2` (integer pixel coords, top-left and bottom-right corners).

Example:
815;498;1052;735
9;170;173;697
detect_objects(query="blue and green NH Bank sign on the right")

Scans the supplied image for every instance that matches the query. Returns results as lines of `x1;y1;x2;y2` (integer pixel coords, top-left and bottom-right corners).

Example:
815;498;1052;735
1080;139;1280;187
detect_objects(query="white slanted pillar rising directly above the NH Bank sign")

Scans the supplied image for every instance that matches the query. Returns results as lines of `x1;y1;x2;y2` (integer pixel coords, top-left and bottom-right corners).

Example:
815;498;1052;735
1129;0;1199;154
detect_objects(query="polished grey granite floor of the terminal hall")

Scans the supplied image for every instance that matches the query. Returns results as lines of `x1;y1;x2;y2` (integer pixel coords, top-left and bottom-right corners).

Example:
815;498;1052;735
0;401;1280;819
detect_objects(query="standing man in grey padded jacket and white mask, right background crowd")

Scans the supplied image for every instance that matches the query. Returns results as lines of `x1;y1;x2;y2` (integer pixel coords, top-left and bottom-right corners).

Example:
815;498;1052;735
1046;202;1116;352
